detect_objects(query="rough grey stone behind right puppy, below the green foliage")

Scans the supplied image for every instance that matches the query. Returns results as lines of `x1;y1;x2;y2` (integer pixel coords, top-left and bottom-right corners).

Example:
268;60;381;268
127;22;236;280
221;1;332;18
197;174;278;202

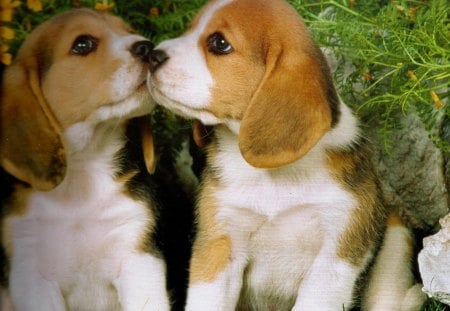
372;113;449;232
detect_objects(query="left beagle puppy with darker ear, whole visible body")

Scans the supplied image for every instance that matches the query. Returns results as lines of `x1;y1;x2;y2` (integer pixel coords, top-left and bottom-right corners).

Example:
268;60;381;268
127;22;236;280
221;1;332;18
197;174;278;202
0;9;169;311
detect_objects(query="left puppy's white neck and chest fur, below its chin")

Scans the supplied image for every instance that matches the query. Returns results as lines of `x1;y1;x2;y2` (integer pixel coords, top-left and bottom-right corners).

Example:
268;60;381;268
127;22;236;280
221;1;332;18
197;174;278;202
7;123;153;310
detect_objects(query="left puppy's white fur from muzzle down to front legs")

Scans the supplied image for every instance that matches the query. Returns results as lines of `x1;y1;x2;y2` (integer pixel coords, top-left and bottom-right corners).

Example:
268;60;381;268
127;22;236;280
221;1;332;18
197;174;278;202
5;29;169;311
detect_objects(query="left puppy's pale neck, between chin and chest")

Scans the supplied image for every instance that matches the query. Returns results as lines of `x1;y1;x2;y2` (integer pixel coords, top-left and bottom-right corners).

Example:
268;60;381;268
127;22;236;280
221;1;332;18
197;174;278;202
42;121;126;202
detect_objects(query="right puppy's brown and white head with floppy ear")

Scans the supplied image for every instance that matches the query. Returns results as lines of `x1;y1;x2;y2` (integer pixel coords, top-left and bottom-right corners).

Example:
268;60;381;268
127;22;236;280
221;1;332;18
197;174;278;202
148;0;338;168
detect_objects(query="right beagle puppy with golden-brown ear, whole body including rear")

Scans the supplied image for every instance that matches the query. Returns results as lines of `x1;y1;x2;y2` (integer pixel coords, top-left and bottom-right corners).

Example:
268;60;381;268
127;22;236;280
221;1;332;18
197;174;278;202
147;0;423;311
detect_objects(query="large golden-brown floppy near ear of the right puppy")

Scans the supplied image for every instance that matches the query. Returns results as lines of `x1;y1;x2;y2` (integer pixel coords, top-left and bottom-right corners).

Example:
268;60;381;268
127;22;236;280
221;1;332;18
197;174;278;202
239;39;338;168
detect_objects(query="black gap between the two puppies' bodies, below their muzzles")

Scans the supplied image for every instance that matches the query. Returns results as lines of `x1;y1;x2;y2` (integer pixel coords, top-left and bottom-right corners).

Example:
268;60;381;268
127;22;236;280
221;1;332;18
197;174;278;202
116;117;194;310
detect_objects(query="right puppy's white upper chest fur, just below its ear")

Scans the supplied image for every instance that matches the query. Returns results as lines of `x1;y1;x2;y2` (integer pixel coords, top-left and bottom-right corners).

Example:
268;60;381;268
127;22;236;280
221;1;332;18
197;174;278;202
216;127;354;220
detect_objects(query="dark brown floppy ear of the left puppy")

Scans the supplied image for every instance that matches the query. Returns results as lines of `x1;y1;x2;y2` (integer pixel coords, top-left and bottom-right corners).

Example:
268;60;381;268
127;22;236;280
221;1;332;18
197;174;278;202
0;57;66;191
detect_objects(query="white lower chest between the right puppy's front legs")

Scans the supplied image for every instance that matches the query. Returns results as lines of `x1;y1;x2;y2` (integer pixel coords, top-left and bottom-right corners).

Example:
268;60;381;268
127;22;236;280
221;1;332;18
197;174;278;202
243;210;324;303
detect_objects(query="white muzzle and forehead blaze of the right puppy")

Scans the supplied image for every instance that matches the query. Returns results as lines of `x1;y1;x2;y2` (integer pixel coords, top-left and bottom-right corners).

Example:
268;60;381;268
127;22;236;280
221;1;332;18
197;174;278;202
147;0;232;124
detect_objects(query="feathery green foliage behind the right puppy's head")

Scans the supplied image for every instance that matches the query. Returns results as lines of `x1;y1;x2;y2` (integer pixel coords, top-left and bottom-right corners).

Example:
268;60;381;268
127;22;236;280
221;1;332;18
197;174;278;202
291;0;450;151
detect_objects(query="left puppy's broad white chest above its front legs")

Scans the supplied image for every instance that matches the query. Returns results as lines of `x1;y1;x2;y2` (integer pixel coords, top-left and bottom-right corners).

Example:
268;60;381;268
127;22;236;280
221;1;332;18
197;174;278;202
10;195;150;300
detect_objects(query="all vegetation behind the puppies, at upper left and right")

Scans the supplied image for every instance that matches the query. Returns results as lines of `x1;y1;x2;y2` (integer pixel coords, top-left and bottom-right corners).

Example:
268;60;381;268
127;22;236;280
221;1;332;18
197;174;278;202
0;0;450;311
